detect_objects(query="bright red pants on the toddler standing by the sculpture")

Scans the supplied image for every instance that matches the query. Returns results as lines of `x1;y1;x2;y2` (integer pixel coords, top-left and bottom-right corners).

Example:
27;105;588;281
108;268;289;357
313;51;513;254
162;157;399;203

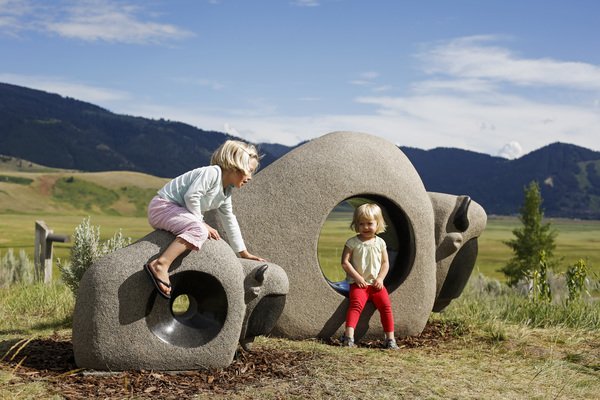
346;283;394;332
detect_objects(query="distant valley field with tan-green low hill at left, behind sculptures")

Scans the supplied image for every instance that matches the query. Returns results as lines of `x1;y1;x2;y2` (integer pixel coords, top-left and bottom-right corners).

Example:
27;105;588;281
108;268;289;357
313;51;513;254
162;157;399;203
0;157;600;282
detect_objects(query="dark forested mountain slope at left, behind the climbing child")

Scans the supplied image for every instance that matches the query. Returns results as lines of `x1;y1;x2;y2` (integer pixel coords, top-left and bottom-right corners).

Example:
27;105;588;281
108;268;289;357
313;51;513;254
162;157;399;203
0;82;276;178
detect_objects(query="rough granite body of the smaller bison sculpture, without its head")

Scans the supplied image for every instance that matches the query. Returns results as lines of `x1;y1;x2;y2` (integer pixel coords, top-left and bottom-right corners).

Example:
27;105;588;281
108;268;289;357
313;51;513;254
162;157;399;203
73;231;246;370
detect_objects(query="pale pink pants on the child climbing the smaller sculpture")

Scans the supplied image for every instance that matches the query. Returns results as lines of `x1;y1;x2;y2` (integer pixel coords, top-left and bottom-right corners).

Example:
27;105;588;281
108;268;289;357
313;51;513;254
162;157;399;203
148;196;208;250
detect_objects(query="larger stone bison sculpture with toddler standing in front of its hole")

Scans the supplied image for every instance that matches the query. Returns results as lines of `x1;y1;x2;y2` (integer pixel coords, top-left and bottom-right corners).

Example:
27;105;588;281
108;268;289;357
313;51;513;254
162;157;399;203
207;132;486;338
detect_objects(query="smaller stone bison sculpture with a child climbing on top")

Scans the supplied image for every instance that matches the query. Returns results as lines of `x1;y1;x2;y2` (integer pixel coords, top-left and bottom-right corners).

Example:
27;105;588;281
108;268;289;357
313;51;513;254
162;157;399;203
73;231;288;370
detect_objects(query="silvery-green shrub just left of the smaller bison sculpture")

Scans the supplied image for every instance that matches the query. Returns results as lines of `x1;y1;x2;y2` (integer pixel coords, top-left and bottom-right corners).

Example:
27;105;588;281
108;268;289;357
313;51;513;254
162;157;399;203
57;217;131;296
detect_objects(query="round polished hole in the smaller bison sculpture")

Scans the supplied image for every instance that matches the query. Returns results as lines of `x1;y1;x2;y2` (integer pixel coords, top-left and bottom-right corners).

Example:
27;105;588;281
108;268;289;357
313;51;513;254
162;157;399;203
146;271;228;348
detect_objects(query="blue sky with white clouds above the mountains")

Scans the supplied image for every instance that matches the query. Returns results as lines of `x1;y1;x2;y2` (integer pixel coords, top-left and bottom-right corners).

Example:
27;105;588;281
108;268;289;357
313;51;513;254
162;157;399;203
0;0;600;158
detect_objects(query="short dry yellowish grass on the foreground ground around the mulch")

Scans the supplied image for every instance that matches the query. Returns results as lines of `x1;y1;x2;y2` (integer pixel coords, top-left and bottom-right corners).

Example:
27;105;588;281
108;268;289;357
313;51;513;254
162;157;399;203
0;282;600;400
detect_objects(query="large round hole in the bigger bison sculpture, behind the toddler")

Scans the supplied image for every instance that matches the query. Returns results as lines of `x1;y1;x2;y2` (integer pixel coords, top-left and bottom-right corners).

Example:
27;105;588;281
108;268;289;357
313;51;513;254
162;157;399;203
318;195;415;296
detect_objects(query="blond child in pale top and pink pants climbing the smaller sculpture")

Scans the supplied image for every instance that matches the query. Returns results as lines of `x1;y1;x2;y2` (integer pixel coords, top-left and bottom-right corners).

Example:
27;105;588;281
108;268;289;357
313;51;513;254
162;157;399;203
144;140;264;299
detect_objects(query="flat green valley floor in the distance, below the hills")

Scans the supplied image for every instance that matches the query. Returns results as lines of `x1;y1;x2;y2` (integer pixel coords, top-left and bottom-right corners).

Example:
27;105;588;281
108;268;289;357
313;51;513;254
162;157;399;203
0;210;600;282
